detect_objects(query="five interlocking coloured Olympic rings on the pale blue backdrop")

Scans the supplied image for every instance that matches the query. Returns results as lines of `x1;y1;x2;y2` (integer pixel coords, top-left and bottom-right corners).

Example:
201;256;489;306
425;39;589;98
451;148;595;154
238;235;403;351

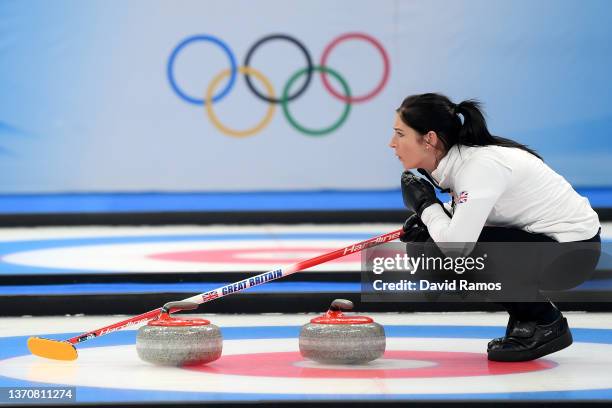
167;33;390;137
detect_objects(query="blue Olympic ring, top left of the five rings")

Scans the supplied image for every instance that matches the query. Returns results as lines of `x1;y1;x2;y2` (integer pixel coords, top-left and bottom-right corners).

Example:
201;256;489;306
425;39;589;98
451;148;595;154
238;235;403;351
167;34;238;105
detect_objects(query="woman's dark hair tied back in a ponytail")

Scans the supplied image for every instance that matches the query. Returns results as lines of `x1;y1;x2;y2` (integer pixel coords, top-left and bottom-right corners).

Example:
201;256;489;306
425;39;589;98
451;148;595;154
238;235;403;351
397;93;542;159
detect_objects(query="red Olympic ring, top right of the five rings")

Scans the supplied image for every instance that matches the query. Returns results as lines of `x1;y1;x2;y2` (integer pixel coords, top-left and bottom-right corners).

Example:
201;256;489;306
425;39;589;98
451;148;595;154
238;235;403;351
319;33;390;103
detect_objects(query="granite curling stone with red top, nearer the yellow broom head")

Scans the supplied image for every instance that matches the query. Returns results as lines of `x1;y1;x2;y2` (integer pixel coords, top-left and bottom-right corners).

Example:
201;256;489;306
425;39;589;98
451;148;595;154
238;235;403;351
136;302;223;366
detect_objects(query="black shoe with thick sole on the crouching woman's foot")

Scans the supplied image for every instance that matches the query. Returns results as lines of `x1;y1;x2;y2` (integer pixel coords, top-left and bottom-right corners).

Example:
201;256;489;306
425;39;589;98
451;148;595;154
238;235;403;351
487;315;573;362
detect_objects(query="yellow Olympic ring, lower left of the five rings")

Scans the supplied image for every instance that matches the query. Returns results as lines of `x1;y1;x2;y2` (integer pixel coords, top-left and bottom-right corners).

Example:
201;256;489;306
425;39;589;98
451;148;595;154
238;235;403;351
204;66;276;137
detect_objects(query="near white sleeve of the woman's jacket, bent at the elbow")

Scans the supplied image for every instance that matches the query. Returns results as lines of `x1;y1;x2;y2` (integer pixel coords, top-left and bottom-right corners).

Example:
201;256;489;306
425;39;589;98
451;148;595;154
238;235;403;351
421;157;512;242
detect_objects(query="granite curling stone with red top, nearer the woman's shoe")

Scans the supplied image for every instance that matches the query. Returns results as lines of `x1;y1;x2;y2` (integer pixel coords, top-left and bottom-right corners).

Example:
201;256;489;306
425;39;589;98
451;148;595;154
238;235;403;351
300;299;386;364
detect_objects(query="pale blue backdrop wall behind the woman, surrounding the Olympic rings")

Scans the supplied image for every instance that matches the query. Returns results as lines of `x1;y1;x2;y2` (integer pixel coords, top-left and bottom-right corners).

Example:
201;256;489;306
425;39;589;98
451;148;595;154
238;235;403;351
0;0;612;194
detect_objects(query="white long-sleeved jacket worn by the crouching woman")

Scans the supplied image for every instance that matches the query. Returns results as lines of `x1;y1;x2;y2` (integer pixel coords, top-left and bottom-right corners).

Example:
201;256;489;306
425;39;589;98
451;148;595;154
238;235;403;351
421;145;600;242
